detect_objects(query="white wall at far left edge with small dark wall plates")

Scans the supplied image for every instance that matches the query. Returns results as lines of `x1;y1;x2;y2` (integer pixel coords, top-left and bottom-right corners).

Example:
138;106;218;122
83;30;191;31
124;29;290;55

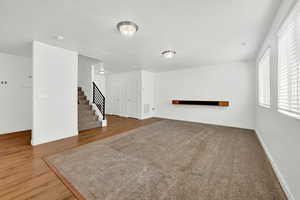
0;53;32;134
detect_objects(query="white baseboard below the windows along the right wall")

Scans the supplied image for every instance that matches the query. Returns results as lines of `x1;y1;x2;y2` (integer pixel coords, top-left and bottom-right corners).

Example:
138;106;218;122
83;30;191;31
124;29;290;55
255;130;296;200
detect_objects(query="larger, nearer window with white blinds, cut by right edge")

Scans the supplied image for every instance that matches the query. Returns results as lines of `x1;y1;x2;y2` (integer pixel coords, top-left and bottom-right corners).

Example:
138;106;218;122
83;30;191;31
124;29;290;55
278;1;300;119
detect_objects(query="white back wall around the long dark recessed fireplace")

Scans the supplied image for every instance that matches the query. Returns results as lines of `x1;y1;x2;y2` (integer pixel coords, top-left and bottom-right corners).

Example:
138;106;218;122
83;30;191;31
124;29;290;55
155;62;255;129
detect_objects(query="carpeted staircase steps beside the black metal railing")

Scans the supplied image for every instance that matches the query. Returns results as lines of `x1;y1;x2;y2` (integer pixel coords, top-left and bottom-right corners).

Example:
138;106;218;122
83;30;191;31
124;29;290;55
78;87;101;131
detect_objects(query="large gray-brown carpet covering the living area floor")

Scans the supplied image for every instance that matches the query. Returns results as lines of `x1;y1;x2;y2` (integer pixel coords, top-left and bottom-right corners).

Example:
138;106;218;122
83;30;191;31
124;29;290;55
47;120;286;200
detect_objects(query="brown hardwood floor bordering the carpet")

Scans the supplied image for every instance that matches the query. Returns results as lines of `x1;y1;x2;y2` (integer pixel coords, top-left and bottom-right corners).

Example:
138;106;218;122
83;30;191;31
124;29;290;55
0;116;160;200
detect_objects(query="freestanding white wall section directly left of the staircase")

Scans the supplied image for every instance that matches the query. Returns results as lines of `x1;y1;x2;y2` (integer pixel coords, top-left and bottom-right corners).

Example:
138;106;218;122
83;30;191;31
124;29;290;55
31;41;78;145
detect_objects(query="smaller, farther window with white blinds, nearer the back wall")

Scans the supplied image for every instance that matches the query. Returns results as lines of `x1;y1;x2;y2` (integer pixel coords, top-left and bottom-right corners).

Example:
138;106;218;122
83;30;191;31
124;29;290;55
258;49;271;108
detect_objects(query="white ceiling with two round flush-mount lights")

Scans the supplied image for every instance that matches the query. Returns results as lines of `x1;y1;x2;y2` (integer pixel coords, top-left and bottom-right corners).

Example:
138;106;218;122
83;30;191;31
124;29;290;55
0;0;281;72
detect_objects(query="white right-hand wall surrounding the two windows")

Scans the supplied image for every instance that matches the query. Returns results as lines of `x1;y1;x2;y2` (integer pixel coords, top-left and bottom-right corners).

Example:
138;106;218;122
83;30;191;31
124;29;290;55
256;0;300;199
